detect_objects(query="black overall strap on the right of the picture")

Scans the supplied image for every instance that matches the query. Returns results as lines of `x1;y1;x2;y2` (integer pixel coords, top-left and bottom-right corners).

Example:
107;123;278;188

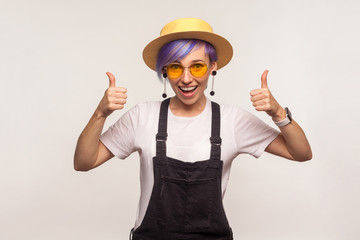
210;102;221;160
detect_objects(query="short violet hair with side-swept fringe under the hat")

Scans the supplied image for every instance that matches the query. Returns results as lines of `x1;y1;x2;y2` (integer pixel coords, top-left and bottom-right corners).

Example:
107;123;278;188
156;39;218;80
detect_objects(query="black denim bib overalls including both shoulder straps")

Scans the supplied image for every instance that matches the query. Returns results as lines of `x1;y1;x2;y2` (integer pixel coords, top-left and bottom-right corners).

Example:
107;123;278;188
130;99;233;240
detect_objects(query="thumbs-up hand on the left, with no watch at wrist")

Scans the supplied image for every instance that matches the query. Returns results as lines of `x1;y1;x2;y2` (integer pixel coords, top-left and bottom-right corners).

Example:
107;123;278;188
97;72;127;117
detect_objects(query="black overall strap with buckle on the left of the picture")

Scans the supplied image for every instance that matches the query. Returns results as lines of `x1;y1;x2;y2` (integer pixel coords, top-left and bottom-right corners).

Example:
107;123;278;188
156;98;170;158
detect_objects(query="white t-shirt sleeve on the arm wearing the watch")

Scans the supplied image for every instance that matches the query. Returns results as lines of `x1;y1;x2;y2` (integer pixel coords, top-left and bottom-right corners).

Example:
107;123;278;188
235;109;280;158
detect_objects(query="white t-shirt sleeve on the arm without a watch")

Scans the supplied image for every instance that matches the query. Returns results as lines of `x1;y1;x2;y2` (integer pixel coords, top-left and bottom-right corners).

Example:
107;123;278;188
100;106;139;159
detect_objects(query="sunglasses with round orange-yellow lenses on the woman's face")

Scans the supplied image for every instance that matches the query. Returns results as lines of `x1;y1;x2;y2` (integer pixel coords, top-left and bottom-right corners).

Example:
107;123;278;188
165;62;208;79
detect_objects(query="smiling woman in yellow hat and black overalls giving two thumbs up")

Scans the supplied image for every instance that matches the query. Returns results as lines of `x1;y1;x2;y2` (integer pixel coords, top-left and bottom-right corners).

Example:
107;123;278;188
74;18;312;240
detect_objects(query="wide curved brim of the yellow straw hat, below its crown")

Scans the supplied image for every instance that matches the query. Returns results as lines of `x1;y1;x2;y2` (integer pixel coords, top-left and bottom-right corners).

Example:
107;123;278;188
143;31;233;71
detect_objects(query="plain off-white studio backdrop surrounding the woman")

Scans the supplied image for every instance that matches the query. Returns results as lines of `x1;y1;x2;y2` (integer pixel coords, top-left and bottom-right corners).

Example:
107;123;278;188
0;0;360;240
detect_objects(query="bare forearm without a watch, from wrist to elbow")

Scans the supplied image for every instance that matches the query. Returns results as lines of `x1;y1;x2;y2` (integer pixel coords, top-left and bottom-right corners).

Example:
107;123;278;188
74;111;106;171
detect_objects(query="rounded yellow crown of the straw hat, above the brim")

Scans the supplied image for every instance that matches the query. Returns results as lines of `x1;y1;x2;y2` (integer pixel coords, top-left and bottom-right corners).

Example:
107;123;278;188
160;18;214;36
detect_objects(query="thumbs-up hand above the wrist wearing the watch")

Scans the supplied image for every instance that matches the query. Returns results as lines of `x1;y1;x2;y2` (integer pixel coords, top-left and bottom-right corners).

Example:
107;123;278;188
250;70;286;122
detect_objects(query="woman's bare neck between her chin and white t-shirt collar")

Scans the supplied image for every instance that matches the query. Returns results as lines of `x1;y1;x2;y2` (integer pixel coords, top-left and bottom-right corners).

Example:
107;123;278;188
170;95;206;117
